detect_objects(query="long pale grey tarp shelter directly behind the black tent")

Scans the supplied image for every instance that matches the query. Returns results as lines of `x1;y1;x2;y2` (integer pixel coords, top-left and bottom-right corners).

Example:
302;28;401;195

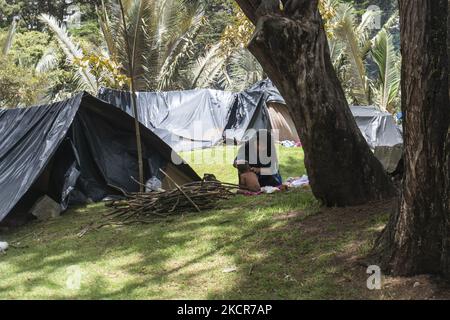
98;88;235;151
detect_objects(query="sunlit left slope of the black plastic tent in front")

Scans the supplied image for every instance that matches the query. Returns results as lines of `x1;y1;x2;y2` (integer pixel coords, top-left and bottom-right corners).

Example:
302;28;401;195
0;95;82;221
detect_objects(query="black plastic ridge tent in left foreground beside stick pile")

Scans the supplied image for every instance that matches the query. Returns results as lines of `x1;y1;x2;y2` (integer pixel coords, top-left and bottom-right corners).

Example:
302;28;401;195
0;93;200;222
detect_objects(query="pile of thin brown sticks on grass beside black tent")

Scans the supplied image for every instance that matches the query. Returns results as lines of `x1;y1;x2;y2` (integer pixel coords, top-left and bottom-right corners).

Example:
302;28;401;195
78;172;239;237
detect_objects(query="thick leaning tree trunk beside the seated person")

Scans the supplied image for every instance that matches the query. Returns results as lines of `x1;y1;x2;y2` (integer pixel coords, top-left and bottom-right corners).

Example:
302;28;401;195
236;0;395;206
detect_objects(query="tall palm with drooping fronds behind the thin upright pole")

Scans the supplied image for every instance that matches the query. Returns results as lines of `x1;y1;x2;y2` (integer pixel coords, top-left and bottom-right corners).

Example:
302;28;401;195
97;0;204;91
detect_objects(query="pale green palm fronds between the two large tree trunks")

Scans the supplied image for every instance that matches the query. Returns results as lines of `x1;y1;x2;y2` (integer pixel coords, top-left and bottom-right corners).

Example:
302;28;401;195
328;0;400;111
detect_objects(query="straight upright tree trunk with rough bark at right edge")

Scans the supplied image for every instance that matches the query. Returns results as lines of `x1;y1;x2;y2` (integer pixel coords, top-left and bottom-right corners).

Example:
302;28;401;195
378;0;450;276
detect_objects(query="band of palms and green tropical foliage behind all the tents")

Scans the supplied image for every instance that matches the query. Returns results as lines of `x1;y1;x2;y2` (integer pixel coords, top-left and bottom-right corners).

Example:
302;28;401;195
0;0;400;111
